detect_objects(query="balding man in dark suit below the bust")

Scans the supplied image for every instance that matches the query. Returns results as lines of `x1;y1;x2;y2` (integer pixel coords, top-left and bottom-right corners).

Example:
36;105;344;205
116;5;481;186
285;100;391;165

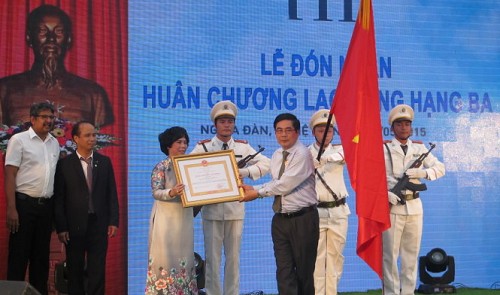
54;121;118;294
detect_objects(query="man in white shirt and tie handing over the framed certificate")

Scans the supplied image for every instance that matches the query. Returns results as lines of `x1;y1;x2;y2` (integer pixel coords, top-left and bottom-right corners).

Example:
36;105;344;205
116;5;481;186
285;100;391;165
240;113;319;295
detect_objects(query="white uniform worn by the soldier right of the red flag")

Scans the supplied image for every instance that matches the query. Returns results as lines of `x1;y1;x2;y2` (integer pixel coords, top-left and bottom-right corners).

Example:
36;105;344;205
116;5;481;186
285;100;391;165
383;138;445;295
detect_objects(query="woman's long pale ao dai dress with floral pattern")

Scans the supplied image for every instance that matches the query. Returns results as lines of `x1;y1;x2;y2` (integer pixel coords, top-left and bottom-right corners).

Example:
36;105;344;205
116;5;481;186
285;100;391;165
145;159;198;295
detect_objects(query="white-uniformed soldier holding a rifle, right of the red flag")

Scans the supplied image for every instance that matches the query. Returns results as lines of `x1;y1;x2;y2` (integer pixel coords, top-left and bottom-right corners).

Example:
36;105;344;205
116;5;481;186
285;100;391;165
383;104;445;295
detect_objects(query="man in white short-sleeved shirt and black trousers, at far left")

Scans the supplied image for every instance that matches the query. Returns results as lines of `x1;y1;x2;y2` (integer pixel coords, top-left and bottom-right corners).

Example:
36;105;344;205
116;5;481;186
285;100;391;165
4;102;59;294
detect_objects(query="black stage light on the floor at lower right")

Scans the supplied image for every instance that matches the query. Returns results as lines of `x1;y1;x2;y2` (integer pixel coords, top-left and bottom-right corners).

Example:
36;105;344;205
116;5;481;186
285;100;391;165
417;248;457;294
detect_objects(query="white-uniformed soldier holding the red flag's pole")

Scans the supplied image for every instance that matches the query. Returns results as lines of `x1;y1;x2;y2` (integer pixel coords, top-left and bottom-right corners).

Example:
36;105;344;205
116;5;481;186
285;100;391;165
309;110;351;295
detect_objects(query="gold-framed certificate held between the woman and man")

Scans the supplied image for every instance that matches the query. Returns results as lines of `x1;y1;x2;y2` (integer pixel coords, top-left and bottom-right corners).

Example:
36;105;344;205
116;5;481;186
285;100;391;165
172;150;243;207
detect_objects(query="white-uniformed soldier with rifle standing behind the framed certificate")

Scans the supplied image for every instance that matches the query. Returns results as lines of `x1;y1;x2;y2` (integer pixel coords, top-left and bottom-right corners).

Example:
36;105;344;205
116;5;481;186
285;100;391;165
191;101;270;295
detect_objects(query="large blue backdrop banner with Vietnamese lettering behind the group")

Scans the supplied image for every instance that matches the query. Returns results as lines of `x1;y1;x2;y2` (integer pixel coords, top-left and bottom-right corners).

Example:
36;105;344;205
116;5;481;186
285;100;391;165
128;0;500;294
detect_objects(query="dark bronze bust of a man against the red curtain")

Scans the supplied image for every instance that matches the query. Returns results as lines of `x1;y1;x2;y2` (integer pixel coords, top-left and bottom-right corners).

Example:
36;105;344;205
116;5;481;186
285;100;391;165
0;5;114;127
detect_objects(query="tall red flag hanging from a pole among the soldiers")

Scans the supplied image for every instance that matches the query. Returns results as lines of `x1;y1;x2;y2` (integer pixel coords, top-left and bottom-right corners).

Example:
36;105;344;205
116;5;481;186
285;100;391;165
330;0;390;278
